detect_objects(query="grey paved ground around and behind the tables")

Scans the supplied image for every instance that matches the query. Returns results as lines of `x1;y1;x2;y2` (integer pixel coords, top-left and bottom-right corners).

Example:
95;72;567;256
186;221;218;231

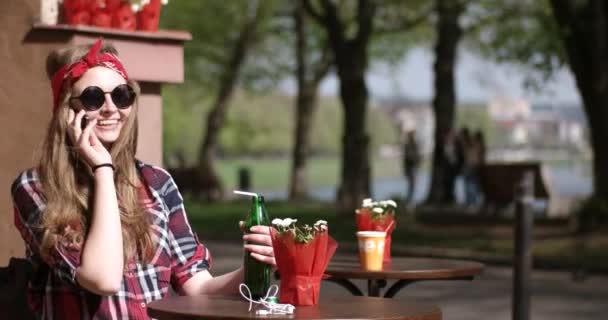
206;243;608;320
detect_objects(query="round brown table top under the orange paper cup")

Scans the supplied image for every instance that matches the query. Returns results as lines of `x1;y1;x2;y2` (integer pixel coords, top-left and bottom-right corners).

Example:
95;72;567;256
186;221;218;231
325;257;484;280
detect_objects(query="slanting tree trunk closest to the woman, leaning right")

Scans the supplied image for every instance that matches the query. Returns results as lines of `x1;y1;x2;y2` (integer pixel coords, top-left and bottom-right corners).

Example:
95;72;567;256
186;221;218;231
197;5;260;201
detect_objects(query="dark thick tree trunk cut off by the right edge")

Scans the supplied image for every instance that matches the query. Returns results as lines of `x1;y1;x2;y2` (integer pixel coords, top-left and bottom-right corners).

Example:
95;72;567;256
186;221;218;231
551;0;608;200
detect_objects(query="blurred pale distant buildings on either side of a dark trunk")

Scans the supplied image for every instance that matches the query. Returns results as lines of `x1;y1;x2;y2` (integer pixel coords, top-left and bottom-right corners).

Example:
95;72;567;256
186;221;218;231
378;97;590;160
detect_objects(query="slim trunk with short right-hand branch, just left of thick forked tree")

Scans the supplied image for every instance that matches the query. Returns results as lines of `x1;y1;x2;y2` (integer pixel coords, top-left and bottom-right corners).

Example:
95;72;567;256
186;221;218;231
289;2;331;200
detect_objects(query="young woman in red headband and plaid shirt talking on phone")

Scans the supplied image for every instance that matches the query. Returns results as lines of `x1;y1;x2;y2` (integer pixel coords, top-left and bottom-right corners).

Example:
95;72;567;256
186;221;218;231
12;39;275;319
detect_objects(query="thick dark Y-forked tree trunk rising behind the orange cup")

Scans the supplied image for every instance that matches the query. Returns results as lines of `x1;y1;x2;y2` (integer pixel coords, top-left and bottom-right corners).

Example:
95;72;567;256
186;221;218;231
302;0;376;215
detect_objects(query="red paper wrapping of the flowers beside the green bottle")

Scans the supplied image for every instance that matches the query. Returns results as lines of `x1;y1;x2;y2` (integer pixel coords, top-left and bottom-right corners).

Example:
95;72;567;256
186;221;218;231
272;229;338;306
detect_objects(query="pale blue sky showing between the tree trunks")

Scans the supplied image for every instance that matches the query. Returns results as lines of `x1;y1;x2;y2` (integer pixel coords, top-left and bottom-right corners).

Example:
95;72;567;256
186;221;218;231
308;48;581;105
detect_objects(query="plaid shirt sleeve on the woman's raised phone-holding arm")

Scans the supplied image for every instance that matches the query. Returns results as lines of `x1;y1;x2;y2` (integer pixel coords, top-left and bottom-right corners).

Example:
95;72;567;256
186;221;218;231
11;169;80;285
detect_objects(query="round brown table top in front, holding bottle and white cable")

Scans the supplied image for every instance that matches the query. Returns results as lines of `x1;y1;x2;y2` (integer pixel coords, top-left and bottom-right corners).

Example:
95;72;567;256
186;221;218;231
148;295;441;320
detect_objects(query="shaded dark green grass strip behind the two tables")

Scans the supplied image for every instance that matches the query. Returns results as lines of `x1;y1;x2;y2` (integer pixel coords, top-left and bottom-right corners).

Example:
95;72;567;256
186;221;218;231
186;197;608;271
